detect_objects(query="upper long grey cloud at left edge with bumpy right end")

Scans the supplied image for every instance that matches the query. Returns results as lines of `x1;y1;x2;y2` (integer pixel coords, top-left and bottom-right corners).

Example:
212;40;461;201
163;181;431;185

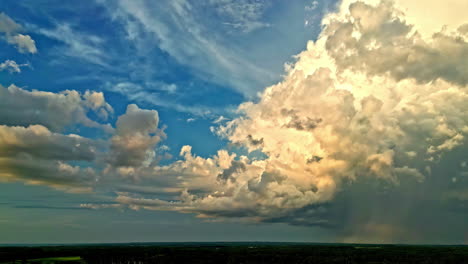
0;85;113;131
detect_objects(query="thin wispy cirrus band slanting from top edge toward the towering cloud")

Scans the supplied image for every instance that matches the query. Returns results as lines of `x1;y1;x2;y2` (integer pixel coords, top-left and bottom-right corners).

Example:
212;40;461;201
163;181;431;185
101;0;274;96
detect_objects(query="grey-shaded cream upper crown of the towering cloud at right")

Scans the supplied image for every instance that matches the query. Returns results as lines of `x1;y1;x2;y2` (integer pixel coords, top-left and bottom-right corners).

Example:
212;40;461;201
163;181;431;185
326;2;468;86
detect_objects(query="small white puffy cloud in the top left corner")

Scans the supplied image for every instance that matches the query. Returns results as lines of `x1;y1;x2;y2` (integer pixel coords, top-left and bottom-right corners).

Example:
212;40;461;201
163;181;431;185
0;13;37;53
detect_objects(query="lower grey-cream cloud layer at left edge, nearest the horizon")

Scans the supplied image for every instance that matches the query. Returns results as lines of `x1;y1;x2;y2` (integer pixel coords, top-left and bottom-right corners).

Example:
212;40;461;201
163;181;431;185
0;125;97;192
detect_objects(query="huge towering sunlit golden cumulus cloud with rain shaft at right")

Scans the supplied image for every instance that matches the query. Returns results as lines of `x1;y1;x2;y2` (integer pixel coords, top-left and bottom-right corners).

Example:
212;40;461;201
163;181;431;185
97;1;468;241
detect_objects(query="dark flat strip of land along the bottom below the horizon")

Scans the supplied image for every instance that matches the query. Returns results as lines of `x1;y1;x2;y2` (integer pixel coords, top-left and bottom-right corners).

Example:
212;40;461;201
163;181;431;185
0;243;468;264
